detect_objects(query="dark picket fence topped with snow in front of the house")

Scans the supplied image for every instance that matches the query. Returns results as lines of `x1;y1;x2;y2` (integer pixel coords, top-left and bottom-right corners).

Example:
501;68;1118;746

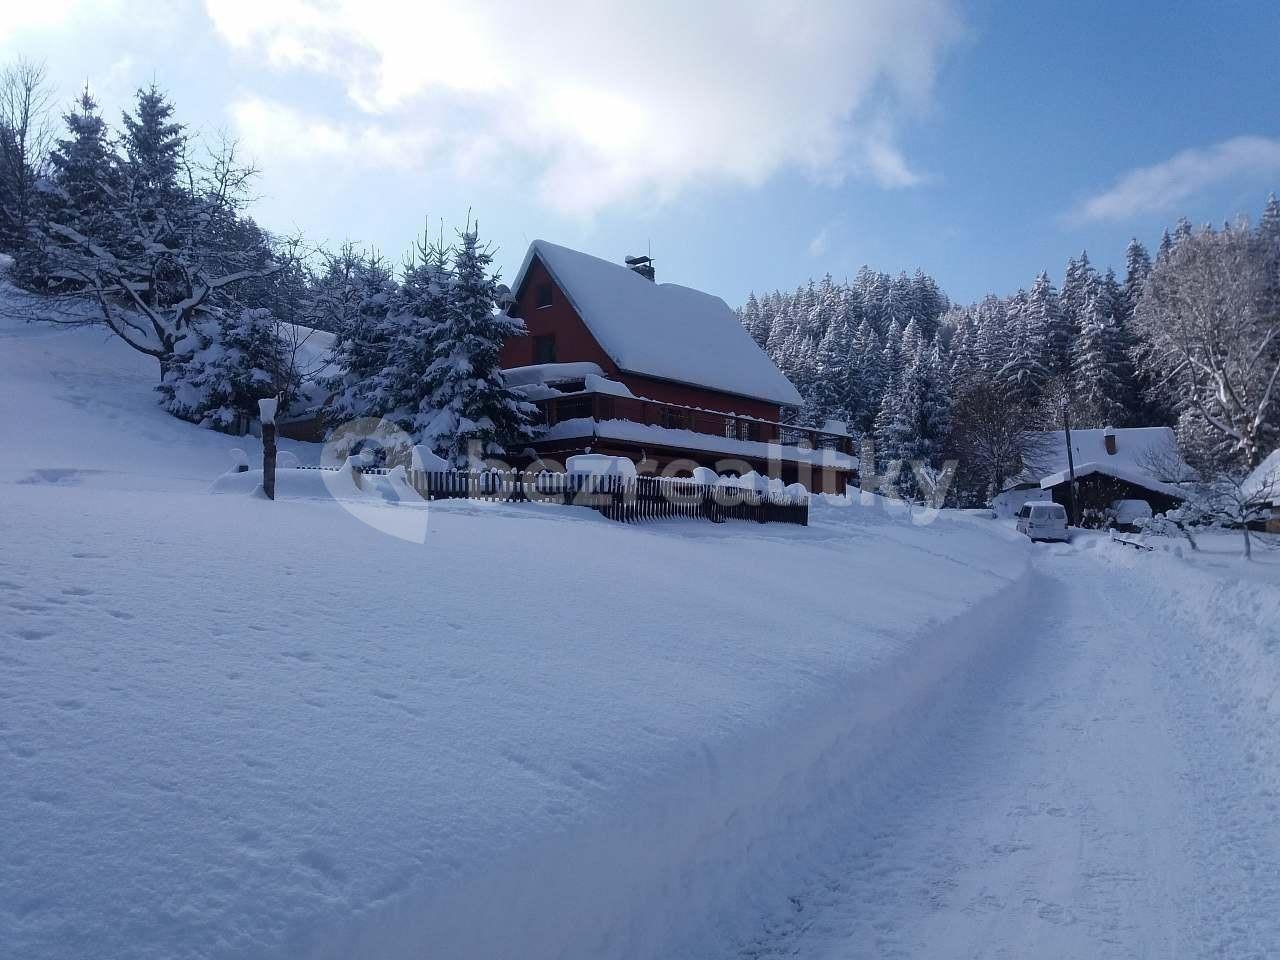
335;467;809;526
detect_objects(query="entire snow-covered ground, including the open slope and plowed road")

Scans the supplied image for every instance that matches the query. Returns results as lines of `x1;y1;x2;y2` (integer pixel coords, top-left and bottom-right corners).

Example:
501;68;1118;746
0;298;1280;960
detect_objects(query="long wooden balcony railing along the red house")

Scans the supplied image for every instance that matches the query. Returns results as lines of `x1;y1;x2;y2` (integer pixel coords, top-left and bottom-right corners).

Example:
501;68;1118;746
538;393;854;456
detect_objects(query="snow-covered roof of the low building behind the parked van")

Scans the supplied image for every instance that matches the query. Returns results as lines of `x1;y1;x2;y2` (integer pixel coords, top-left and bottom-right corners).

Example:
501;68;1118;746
1014;426;1190;485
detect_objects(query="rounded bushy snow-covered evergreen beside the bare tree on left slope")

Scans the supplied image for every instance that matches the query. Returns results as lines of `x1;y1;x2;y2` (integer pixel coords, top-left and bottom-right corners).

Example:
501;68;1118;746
159;307;298;433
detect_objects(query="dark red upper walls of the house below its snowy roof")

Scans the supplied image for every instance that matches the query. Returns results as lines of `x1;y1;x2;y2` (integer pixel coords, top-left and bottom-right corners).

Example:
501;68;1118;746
499;257;781;420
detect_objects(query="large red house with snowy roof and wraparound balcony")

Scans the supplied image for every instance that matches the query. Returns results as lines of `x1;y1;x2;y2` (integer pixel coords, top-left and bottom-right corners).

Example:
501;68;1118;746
502;241;855;493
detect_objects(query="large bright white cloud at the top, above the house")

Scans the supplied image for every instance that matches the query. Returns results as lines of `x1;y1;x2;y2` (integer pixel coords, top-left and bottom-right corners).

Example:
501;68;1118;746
206;0;961;214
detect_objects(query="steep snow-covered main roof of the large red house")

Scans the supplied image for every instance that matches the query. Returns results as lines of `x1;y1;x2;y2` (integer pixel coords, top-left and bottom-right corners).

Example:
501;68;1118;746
513;239;804;406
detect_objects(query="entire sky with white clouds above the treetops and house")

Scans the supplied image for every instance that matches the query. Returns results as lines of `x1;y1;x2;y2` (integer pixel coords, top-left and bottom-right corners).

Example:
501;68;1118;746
0;0;1280;303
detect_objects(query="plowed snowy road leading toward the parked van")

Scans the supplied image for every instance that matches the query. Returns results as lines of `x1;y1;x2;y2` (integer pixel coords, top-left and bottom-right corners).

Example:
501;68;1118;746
737;548;1280;960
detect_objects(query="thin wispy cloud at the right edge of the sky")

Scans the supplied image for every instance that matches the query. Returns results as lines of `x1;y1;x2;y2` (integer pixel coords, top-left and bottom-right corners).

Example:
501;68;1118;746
1068;137;1280;223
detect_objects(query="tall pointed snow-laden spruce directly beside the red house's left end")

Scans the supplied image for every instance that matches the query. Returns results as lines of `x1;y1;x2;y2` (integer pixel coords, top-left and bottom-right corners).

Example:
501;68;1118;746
413;225;536;467
